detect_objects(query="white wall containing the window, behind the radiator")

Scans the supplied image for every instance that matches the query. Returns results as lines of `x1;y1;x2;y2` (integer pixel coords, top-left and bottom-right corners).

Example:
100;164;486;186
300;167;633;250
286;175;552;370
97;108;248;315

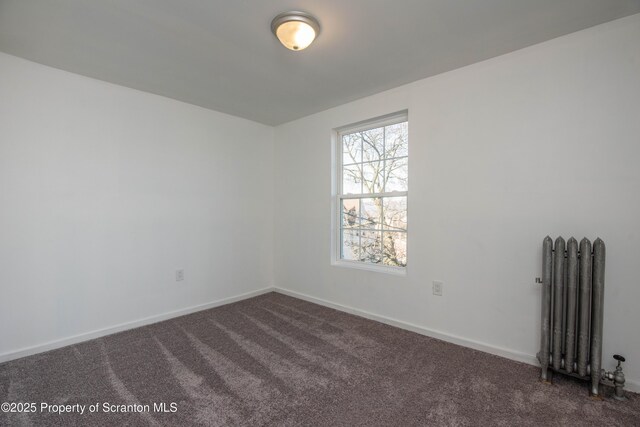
275;15;640;390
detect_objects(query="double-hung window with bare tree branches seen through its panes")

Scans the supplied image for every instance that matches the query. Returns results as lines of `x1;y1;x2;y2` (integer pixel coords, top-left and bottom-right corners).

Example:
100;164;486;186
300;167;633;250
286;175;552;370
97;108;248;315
336;112;409;270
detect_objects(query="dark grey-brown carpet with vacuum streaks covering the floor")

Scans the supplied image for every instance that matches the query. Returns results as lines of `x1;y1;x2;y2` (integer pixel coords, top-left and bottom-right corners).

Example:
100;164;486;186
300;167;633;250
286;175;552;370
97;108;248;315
0;293;640;426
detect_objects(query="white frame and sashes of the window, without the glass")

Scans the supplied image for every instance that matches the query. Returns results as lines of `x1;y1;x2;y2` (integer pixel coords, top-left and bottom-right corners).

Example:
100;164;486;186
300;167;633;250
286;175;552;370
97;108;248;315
331;110;411;276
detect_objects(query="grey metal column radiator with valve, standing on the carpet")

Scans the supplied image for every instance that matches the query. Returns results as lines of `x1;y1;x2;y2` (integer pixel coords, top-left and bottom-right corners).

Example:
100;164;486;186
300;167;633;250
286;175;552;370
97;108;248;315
536;236;624;399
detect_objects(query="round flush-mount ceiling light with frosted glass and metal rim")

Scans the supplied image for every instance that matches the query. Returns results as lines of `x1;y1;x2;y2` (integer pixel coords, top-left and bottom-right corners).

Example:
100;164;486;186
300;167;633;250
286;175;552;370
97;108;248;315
271;11;320;50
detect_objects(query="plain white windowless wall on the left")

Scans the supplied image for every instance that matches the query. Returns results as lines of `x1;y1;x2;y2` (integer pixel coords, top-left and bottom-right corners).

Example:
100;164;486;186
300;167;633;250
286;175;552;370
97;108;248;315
0;54;273;360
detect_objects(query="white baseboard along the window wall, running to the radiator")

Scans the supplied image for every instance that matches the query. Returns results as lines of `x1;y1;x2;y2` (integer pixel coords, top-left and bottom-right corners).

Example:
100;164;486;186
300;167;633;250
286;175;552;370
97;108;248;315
272;287;640;393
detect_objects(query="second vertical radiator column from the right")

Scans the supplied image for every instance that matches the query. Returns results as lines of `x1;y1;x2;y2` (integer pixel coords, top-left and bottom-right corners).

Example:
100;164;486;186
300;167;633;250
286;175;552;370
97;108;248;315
578;237;591;377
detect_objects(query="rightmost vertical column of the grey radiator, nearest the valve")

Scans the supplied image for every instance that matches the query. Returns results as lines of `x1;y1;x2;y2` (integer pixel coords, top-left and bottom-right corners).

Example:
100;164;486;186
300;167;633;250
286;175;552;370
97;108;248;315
591;238;605;396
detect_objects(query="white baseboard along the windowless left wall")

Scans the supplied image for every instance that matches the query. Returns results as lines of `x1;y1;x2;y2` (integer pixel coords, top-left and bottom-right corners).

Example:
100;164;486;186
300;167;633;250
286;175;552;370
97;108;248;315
0;287;274;363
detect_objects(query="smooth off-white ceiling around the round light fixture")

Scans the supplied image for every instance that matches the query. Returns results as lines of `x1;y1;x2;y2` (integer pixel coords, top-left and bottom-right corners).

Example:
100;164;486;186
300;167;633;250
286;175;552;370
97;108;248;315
0;0;640;125
